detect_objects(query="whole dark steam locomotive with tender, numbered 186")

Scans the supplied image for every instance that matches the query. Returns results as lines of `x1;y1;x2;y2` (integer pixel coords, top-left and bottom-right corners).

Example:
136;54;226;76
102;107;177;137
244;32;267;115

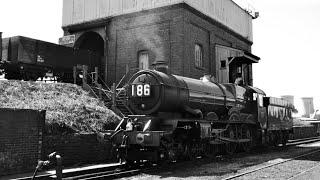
103;70;293;163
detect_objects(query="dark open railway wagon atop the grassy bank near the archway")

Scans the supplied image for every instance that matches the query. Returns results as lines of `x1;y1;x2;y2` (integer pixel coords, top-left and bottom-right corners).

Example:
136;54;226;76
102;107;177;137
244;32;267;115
0;36;101;82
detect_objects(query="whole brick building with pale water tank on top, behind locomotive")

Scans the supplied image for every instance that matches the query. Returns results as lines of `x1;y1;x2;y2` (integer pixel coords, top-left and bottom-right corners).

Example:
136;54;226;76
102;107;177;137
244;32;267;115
60;0;259;85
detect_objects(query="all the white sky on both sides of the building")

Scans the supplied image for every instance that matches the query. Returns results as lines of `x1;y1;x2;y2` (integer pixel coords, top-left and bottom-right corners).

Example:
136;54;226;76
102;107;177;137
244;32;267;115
0;0;320;112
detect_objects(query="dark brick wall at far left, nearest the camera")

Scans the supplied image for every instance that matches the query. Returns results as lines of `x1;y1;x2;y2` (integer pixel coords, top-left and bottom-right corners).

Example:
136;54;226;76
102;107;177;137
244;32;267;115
0;109;45;175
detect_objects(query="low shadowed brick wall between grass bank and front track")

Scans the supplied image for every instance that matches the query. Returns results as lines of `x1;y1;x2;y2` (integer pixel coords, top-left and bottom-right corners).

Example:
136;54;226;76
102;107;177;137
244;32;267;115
43;134;112;165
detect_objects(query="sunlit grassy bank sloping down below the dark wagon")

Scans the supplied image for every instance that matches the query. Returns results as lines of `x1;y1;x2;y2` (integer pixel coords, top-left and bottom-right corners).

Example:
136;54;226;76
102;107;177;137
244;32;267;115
0;81;119;134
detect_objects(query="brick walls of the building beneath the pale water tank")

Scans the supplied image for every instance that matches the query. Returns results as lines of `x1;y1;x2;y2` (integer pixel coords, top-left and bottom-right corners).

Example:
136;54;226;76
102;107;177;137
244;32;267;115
64;4;252;84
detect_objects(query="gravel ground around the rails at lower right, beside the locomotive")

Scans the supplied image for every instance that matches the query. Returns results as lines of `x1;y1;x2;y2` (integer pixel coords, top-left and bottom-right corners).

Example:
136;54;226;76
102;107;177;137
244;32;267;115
122;142;320;180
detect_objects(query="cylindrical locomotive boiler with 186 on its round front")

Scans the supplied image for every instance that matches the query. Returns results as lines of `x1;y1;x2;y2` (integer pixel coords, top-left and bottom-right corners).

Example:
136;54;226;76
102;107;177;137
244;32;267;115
128;71;245;116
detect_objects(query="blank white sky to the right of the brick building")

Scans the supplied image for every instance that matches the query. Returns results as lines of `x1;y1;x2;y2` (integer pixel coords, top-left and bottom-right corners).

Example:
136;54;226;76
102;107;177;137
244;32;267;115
252;0;320;112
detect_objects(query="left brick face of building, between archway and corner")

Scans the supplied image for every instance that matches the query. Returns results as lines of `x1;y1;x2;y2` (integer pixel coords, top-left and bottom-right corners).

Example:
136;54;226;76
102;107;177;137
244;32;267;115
108;5;183;83
